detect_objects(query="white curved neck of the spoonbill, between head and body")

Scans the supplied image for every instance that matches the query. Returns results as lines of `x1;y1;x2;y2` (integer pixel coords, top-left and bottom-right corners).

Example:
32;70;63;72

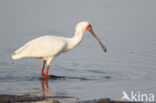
66;30;84;51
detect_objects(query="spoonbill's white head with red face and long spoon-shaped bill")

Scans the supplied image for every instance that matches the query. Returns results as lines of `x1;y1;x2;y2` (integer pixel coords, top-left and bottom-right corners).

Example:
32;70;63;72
76;21;107;52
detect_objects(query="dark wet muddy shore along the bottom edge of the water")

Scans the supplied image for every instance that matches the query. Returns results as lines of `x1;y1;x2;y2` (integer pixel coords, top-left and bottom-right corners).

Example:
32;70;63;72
0;94;143;103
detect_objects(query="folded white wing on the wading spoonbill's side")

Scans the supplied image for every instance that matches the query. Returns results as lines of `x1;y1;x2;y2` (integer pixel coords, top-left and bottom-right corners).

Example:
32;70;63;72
16;36;66;58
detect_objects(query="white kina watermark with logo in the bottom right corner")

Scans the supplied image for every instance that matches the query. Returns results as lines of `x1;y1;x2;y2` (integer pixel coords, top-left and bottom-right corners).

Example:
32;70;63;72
121;91;155;102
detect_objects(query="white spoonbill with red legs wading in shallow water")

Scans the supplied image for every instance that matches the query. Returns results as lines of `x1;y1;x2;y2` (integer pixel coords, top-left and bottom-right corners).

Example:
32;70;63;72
12;21;107;78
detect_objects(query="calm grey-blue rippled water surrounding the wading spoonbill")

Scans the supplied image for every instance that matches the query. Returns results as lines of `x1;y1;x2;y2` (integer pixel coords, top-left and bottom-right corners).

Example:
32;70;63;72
0;0;156;100
